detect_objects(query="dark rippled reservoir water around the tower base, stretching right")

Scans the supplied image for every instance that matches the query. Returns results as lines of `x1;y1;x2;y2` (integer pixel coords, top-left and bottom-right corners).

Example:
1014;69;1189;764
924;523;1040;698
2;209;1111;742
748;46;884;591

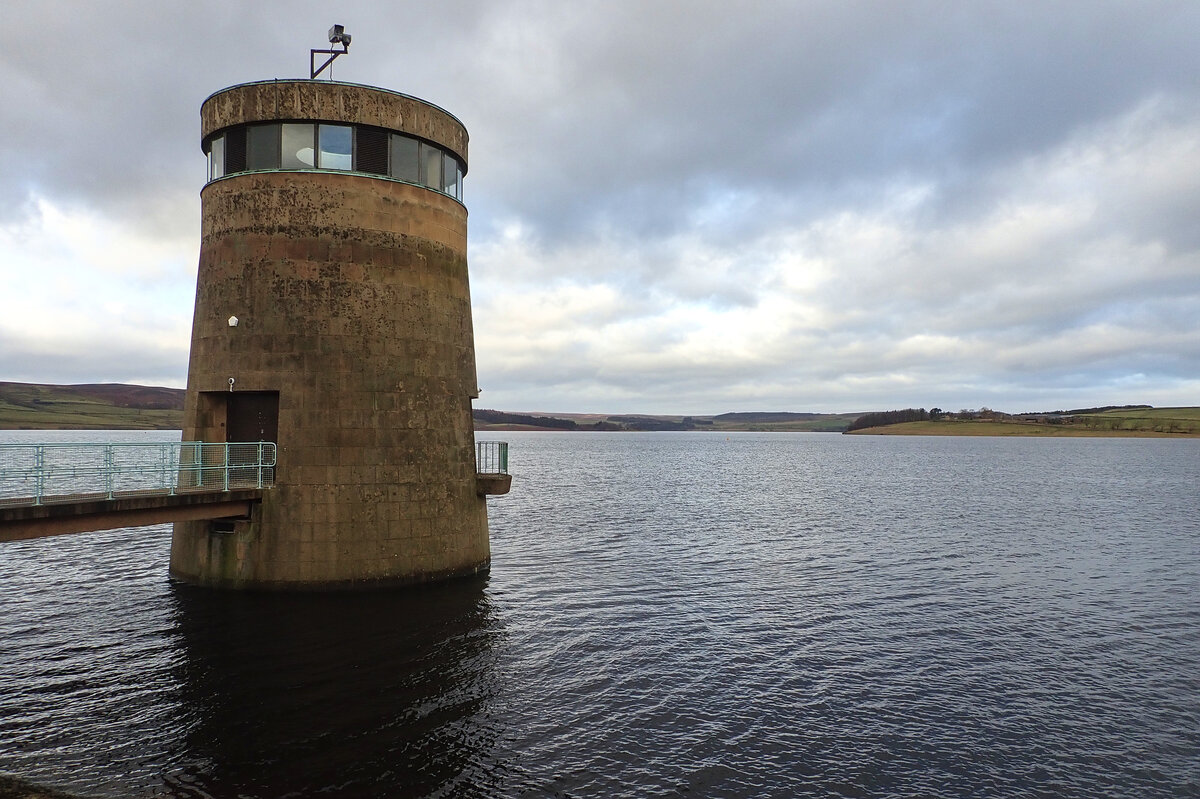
0;433;1200;798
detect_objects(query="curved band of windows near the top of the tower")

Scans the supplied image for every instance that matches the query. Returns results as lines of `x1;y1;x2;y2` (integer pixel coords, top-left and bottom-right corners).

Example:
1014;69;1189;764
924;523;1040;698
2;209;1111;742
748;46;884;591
206;122;463;202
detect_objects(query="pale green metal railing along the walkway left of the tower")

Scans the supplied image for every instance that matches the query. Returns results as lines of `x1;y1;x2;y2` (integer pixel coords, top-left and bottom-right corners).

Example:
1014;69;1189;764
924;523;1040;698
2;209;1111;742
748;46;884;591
0;441;275;505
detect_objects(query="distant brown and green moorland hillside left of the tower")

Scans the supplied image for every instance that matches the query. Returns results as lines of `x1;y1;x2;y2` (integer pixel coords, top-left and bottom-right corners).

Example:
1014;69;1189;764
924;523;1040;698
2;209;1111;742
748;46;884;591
0;383;184;429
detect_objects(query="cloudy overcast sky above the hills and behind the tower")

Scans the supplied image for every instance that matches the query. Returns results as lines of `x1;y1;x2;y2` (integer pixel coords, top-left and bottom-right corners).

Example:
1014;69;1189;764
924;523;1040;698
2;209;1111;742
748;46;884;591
0;0;1200;414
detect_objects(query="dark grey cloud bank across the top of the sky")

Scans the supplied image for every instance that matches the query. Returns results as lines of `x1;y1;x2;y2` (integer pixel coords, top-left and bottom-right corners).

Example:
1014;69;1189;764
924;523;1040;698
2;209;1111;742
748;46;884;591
7;2;1200;242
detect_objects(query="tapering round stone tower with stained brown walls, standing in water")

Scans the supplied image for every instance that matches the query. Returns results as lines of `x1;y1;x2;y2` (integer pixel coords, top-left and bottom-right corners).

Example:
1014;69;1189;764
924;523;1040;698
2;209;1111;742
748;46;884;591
170;80;490;588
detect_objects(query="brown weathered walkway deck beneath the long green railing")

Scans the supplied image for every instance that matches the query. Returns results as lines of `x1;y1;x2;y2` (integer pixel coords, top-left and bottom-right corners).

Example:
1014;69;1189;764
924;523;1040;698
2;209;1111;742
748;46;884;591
0;488;263;541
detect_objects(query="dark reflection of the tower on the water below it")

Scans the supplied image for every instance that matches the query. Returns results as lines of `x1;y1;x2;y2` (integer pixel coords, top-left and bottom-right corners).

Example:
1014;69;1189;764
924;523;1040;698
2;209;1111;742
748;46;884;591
166;577;502;799
